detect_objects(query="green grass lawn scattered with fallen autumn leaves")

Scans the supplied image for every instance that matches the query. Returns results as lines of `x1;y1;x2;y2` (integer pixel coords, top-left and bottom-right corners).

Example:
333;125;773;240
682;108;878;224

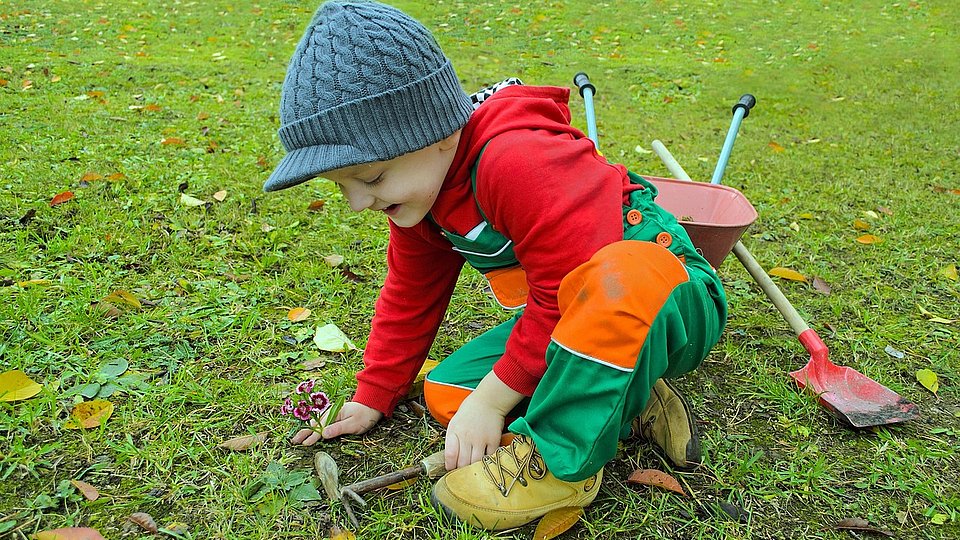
0;0;960;539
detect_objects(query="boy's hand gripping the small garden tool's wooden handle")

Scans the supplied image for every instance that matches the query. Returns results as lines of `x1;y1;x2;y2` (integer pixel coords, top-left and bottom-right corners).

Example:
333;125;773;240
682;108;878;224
443;371;524;470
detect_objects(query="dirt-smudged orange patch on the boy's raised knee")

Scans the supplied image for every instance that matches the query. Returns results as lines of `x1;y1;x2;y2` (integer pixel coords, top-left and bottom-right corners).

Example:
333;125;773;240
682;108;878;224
552;240;689;370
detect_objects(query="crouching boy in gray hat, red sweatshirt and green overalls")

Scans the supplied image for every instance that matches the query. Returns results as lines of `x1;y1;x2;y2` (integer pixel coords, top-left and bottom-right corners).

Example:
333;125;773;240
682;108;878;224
264;2;726;530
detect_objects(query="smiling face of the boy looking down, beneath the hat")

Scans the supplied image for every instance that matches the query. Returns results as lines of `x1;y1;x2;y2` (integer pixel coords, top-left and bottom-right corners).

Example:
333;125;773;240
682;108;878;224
320;131;460;227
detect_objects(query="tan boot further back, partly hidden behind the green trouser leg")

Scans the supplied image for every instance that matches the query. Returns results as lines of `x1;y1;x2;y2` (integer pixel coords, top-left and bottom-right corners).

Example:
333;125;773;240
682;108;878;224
631;379;703;469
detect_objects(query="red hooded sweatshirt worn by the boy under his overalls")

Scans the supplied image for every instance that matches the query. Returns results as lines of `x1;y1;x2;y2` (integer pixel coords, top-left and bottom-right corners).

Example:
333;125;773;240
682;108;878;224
354;86;639;415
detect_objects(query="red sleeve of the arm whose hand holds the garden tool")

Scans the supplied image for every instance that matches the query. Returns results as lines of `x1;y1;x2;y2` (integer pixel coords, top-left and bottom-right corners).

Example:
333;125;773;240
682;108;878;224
477;130;626;395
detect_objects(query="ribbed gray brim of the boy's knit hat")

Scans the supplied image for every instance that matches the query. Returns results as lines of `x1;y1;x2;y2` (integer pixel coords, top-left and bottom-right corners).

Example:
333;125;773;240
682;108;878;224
263;145;381;192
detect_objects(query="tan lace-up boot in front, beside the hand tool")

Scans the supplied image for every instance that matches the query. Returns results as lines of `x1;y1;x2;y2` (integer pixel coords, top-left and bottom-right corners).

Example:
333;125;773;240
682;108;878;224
432;435;603;531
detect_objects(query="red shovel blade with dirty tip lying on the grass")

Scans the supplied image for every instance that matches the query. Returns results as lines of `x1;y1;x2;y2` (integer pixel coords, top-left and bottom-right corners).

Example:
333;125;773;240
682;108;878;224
790;359;920;428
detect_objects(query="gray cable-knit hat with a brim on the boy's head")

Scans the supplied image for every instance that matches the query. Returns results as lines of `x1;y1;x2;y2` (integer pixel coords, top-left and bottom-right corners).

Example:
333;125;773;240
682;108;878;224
263;1;473;191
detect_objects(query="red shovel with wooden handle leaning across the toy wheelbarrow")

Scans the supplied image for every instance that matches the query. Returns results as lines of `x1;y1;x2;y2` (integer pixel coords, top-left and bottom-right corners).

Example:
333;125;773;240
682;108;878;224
653;141;920;428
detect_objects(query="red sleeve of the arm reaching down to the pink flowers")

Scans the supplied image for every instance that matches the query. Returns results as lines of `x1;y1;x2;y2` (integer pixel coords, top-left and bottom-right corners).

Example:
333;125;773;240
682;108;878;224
353;221;464;416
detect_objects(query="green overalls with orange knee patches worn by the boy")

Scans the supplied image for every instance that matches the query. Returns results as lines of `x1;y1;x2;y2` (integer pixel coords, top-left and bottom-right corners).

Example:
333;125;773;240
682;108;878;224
425;168;726;481
